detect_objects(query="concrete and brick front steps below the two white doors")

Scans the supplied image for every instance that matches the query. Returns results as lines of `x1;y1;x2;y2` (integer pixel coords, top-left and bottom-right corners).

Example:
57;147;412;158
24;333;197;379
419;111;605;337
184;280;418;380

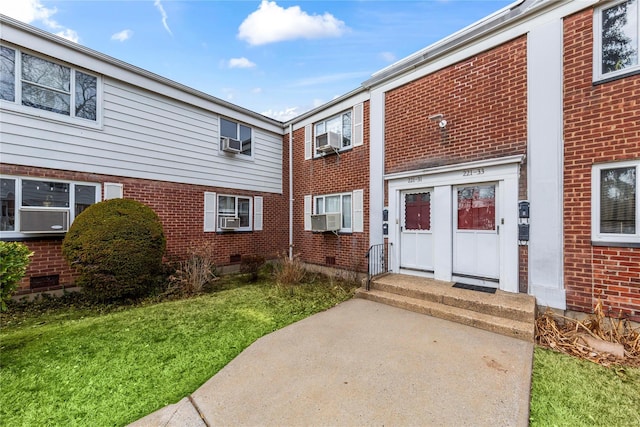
356;274;536;342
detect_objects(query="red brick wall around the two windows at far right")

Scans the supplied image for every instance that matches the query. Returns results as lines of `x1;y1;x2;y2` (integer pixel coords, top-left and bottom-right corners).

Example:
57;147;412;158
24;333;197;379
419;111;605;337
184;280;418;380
564;9;640;320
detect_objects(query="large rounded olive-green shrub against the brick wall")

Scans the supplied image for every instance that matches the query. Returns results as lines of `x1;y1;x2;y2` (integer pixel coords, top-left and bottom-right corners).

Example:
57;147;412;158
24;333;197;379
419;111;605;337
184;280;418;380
62;199;166;300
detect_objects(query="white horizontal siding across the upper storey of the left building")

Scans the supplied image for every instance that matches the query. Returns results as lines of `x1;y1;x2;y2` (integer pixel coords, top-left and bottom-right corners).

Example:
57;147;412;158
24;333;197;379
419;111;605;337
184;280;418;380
0;78;283;193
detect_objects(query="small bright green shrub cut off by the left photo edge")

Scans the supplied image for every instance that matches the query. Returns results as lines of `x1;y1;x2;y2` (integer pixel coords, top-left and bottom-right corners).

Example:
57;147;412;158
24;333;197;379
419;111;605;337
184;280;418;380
0;241;33;311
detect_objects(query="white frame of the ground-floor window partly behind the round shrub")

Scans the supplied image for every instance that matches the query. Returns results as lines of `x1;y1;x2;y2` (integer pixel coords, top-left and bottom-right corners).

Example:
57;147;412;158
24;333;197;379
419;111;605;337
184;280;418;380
0;175;102;238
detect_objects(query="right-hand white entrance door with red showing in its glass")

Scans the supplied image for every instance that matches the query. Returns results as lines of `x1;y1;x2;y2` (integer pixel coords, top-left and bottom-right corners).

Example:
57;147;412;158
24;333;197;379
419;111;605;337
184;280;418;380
453;183;500;287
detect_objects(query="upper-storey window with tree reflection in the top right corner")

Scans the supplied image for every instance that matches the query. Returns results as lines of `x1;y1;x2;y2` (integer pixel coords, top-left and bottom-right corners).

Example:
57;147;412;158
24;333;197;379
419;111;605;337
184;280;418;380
593;0;640;80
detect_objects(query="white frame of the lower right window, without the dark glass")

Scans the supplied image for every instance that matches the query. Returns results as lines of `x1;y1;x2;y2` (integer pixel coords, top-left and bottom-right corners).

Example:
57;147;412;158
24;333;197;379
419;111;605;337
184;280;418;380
591;160;640;246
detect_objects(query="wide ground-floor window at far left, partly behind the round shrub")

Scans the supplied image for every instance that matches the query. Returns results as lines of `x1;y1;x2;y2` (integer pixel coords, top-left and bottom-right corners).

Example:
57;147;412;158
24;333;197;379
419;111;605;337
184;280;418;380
0;177;100;237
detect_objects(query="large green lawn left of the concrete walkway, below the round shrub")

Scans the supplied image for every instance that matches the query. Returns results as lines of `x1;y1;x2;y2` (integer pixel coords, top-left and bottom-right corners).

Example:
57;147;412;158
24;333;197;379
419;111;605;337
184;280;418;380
0;276;358;426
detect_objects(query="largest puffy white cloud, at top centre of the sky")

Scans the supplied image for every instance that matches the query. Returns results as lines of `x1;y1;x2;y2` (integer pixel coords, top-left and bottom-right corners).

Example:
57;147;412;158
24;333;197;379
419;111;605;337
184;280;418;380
238;0;347;46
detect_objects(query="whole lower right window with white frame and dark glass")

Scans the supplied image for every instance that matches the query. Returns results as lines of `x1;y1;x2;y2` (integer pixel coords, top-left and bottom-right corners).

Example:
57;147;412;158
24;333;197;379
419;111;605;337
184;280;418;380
591;160;640;245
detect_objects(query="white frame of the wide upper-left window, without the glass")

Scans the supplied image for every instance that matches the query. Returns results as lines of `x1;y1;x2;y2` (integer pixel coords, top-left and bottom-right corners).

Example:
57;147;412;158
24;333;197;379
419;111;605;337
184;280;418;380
0;43;103;128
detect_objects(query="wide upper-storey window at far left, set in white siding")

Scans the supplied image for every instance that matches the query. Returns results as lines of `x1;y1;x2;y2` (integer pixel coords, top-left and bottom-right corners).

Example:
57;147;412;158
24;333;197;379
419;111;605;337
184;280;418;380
0;46;98;122
